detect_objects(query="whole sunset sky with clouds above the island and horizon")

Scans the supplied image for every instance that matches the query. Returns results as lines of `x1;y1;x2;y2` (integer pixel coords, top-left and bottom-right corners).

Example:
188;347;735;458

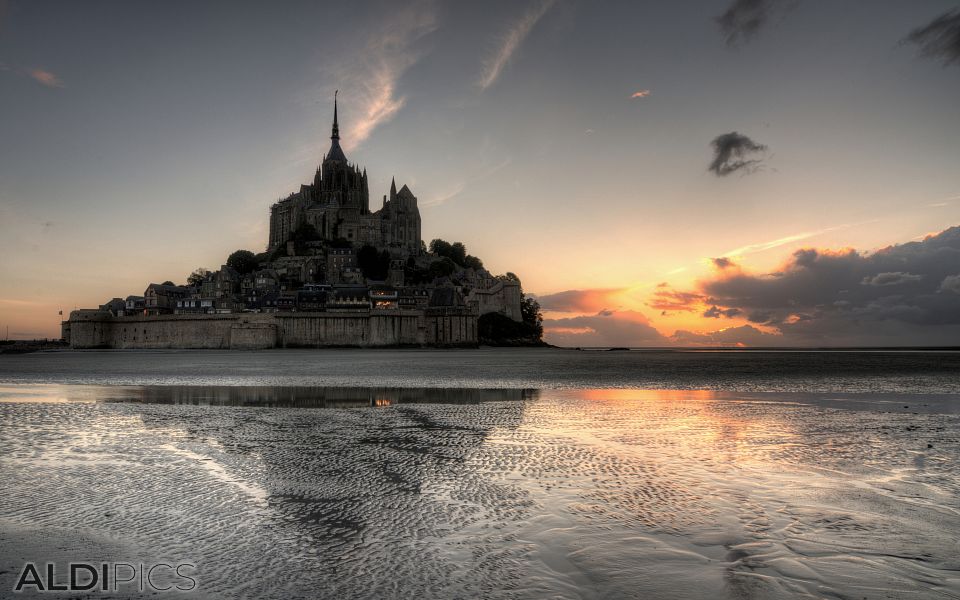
0;0;960;346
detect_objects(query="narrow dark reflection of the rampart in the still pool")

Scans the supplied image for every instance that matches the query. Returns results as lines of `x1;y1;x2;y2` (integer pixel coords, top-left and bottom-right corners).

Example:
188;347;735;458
116;385;537;408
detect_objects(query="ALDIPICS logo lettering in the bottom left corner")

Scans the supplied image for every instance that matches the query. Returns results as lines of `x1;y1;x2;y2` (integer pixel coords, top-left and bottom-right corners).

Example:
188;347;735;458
13;562;197;593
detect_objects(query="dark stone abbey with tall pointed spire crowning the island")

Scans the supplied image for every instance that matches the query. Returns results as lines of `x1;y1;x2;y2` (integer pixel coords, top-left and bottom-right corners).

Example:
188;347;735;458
269;93;421;258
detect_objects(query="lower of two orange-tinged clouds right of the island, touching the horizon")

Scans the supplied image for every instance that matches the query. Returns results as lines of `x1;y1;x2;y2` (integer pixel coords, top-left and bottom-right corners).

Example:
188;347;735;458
543;310;670;347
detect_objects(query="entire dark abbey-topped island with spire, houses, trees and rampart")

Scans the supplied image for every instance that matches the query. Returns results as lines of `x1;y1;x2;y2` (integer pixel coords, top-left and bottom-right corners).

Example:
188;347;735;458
62;95;542;349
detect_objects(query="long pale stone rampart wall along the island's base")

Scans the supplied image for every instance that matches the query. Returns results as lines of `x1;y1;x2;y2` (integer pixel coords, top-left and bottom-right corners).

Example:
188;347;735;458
63;308;477;350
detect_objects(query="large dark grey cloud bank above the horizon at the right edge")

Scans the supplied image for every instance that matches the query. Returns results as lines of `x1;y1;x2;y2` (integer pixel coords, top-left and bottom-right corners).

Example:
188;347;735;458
698;227;960;345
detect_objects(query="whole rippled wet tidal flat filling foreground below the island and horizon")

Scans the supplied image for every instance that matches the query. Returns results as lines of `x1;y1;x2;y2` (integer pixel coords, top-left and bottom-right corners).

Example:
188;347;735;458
0;350;960;598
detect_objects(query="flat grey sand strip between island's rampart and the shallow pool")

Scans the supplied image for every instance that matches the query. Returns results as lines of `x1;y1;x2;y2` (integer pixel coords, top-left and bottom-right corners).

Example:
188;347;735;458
0;348;960;394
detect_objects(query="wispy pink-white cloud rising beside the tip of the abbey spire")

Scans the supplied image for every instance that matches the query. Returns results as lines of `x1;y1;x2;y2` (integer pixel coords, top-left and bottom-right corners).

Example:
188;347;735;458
318;2;438;151
